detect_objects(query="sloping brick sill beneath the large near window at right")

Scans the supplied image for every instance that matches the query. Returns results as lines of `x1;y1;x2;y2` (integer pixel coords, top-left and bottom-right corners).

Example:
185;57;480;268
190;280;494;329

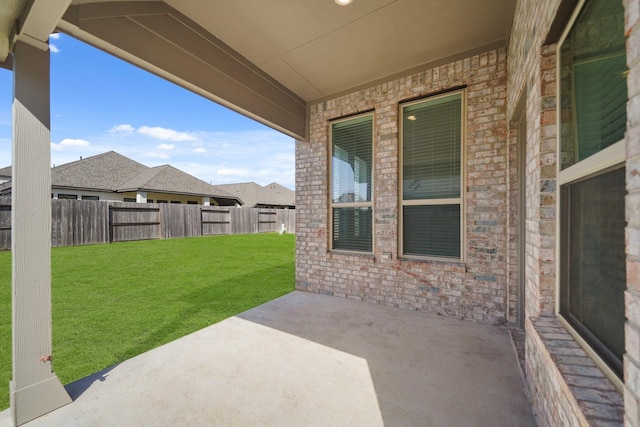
526;317;624;425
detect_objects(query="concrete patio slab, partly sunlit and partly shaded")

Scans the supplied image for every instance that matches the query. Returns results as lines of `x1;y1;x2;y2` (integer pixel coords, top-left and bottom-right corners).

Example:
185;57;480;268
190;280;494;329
0;292;535;427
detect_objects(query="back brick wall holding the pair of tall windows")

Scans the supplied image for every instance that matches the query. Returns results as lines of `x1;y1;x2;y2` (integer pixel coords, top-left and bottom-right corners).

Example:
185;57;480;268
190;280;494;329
296;49;508;323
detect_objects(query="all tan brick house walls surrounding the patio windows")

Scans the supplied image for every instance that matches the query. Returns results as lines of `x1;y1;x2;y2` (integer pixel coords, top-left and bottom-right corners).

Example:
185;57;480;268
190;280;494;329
296;0;640;427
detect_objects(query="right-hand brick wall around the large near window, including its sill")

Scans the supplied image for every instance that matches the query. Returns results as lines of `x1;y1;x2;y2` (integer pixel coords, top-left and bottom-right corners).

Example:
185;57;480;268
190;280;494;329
507;0;640;426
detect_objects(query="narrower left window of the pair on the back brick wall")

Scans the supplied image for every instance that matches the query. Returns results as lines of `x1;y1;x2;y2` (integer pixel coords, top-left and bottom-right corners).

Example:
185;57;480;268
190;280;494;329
331;114;373;252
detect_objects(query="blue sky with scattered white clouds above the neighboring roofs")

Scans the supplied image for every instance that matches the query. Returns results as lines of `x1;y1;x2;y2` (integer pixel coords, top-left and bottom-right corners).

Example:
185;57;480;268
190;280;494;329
0;34;295;189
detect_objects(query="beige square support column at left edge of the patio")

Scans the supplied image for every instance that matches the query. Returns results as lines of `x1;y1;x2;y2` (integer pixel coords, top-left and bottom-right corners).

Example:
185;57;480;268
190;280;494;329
10;41;71;425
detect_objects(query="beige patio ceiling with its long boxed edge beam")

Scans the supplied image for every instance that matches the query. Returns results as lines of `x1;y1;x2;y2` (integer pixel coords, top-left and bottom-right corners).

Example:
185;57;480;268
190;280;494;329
0;0;515;137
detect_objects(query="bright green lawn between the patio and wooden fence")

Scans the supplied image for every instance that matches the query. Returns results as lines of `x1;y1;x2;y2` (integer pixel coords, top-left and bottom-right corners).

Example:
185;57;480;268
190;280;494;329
0;234;294;410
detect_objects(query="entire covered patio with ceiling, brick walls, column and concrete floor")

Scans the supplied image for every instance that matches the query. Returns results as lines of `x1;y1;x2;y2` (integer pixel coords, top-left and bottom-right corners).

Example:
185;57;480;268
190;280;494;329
0;0;640;427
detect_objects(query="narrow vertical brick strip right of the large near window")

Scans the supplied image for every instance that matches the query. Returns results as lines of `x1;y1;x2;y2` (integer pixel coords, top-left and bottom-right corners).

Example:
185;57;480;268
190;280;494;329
624;0;640;427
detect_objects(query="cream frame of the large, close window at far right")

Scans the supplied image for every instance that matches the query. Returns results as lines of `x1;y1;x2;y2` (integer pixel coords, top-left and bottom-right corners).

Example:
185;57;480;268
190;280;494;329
555;0;626;391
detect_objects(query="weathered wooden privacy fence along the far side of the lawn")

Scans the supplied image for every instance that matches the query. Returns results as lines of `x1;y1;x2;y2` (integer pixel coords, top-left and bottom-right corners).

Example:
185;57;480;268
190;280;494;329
0;197;296;249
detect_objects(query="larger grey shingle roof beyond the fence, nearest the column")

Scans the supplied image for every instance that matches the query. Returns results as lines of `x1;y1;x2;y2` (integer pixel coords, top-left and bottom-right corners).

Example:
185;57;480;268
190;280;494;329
0;151;242;204
